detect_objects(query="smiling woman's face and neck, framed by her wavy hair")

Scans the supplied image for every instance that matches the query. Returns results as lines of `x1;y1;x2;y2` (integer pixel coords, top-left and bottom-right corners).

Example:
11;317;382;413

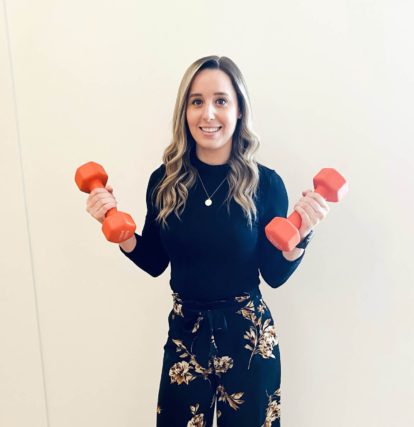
186;69;240;161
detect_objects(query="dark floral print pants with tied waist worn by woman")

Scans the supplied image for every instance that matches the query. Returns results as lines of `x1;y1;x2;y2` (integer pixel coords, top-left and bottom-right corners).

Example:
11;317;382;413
157;287;280;427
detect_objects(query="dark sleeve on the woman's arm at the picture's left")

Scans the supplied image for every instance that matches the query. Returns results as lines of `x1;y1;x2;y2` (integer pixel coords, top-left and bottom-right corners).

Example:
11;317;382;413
119;170;170;277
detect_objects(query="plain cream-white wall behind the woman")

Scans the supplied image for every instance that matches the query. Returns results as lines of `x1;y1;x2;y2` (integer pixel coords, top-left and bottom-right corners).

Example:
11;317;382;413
0;0;414;427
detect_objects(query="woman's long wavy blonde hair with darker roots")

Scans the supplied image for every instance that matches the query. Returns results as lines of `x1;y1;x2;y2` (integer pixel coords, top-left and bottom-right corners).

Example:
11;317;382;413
151;55;260;232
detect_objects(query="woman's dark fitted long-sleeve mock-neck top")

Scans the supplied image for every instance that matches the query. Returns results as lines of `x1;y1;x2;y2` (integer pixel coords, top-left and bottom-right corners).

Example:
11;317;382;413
119;150;305;301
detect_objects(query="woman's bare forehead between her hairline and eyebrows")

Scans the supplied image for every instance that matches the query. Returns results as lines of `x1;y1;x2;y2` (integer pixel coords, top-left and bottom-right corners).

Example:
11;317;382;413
189;69;236;96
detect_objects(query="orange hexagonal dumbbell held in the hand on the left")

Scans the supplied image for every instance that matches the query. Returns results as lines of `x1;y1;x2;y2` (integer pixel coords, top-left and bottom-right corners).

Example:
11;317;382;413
75;162;136;243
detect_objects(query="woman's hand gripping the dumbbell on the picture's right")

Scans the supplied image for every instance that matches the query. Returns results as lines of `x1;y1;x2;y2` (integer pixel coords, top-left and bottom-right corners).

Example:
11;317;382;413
294;190;329;240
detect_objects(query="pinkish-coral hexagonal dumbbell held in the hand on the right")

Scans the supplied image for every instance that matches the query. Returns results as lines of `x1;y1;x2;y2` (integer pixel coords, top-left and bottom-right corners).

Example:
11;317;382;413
265;168;348;252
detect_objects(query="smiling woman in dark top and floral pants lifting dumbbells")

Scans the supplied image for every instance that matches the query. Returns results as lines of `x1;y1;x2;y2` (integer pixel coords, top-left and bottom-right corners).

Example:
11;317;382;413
87;56;329;427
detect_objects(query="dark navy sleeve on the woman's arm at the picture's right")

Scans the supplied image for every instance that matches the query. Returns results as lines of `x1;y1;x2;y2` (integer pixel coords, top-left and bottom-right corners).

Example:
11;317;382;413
259;170;305;288
